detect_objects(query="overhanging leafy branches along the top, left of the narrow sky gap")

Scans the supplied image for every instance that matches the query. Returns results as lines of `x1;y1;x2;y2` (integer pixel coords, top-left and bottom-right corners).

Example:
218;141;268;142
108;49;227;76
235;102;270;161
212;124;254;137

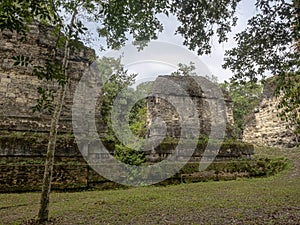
0;0;243;54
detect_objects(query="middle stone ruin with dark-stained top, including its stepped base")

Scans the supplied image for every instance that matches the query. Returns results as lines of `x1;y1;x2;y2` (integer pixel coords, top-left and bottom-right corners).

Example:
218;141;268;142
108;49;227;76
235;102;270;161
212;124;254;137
146;76;254;161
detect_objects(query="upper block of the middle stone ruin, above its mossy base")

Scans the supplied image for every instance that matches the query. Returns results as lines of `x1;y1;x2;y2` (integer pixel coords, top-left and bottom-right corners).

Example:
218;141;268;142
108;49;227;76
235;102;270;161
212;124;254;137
147;76;234;137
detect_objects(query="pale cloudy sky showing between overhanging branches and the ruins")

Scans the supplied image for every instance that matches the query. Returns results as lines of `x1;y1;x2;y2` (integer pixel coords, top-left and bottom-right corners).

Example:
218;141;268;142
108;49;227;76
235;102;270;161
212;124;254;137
87;0;256;83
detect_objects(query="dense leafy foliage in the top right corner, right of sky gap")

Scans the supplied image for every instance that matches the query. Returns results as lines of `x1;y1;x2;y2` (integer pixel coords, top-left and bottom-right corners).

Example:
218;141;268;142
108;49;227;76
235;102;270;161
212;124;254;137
224;0;299;81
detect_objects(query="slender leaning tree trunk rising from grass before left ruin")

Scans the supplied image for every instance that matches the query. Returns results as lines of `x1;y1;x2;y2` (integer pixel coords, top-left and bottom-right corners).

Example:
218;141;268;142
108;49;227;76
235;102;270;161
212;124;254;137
38;9;77;223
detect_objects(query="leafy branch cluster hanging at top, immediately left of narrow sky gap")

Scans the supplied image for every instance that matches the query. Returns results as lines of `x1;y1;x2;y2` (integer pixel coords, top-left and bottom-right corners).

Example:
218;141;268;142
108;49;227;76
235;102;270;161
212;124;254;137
170;0;240;55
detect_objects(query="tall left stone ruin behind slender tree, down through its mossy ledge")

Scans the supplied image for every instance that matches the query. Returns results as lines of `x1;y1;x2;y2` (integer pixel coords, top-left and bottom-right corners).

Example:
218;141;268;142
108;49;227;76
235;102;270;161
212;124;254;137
0;24;95;156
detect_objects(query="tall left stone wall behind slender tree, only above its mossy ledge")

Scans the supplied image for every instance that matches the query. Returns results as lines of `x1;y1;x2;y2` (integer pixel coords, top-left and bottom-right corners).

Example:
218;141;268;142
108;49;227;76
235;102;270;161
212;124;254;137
0;24;94;132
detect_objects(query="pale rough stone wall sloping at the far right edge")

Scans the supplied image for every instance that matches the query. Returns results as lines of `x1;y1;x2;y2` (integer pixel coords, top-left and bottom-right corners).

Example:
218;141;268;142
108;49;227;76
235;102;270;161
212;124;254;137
243;79;296;147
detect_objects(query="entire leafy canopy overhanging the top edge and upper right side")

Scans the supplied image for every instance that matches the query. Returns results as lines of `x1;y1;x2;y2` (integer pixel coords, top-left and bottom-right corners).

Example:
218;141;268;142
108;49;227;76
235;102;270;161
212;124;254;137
0;0;300;136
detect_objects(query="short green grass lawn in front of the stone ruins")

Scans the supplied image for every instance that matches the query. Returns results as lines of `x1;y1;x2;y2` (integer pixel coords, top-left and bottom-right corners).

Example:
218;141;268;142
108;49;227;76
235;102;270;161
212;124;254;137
0;148;300;225
